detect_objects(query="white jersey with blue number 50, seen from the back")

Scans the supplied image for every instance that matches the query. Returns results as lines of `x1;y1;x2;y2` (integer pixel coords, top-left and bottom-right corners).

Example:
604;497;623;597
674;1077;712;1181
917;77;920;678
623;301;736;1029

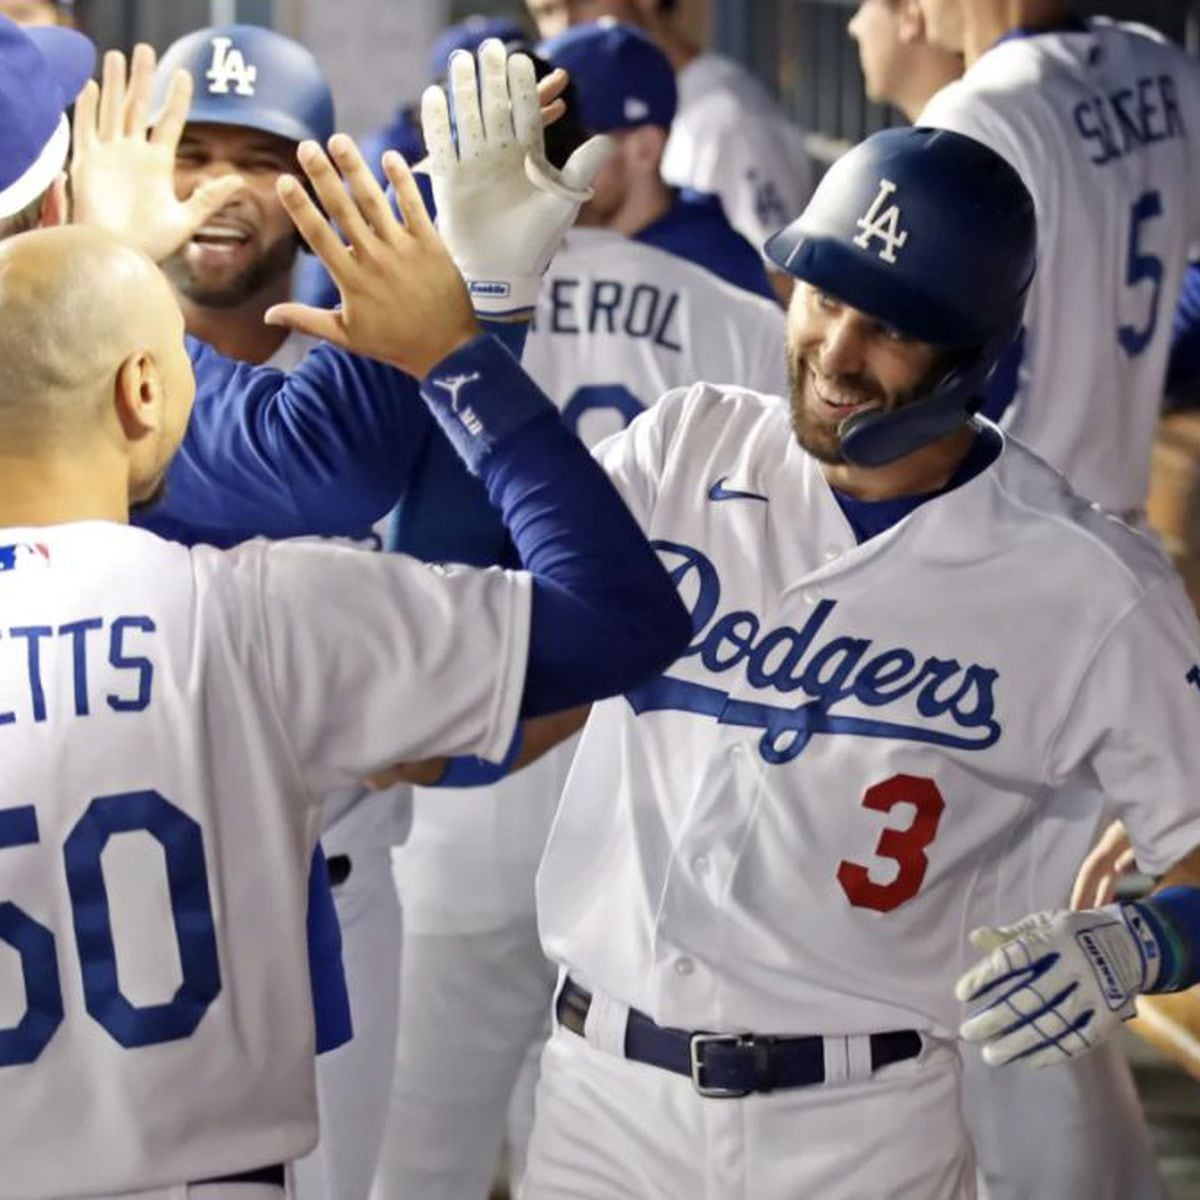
0;522;529;1200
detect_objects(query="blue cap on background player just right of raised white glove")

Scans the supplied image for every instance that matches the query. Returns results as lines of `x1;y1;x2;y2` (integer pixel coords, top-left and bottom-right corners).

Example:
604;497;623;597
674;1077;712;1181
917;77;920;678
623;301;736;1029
538;18;679;133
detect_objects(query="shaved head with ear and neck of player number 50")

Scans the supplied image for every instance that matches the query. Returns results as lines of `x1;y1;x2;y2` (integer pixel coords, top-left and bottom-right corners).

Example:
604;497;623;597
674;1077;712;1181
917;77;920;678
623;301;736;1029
0;226;196;524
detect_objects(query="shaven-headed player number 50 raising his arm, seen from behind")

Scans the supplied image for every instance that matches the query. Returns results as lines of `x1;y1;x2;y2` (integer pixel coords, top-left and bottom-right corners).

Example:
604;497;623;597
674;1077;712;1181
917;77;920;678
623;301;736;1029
0;114;686;1200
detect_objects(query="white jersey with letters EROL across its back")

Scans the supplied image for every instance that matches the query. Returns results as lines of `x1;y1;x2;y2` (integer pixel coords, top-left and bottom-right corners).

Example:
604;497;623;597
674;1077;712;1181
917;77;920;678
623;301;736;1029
396;229;787;934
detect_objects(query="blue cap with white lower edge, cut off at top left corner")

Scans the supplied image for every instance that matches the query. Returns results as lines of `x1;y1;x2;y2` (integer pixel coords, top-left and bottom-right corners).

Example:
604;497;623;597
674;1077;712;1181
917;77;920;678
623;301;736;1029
0;17;96;218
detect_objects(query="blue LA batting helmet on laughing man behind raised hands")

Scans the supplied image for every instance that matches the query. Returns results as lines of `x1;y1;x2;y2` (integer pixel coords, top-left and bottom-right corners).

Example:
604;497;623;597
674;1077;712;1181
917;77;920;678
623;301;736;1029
155;25;334;145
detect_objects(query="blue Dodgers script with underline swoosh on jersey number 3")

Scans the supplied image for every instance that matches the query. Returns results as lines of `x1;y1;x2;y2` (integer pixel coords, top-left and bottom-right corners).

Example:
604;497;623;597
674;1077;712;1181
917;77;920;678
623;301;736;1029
626;541;1002;763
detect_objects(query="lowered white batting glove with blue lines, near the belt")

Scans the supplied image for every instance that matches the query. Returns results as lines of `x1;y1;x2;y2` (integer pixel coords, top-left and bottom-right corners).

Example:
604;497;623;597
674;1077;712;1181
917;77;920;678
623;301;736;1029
954;905;1158;1067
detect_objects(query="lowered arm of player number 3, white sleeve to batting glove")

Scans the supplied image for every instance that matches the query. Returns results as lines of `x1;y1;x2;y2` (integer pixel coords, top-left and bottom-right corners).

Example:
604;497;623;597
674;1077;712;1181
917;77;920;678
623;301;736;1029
956;574;1200;1066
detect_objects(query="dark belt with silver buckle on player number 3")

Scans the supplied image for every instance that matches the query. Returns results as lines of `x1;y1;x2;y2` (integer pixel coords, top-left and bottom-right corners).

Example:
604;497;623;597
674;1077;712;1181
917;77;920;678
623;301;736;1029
554;979;920;1099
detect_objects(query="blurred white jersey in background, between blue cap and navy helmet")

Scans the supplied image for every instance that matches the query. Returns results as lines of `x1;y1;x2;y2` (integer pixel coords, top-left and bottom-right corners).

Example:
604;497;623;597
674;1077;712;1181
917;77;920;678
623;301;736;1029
662;54;816;258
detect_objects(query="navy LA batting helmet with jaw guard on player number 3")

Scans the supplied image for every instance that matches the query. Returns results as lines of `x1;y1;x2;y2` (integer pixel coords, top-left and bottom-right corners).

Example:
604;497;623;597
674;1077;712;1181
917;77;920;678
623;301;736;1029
766;128;1037;467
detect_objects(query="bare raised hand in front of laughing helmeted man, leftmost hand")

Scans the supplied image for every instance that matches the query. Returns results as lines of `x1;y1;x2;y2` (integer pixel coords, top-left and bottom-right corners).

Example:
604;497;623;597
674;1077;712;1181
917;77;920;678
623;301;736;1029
71;44;242;262
